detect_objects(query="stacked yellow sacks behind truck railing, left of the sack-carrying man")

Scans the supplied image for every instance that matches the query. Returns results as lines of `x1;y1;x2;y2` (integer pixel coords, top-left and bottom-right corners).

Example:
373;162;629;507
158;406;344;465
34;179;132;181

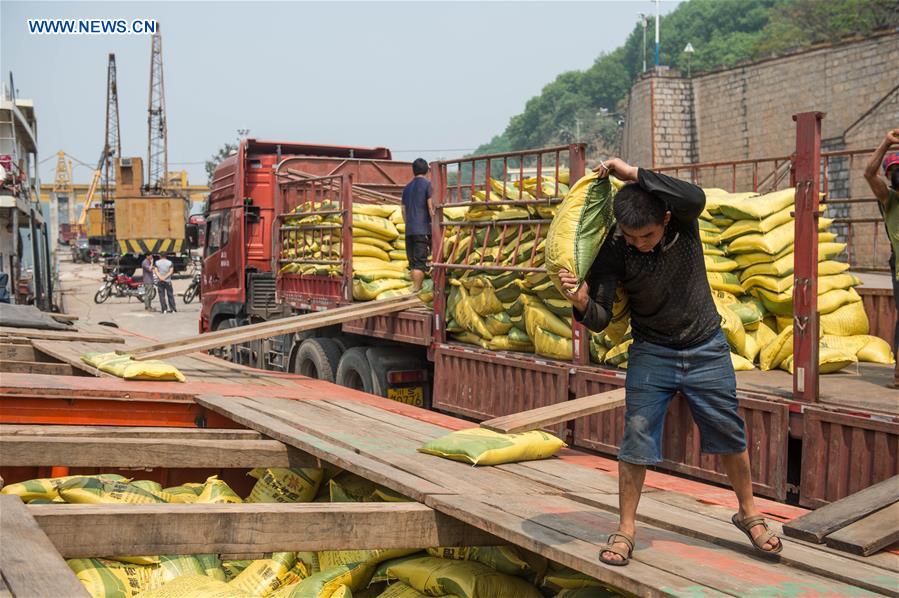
443;171;572;360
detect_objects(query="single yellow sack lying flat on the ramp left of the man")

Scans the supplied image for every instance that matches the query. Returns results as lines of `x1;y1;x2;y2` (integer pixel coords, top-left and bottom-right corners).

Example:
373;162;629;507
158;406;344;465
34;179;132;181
418;428;565;465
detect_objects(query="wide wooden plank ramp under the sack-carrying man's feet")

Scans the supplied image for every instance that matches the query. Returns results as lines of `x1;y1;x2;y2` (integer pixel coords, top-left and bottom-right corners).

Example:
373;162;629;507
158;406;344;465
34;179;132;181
198;393;899;596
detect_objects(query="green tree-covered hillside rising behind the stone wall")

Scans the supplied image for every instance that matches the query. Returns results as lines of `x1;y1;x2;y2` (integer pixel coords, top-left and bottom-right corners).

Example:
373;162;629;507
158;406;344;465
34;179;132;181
474;0;899;159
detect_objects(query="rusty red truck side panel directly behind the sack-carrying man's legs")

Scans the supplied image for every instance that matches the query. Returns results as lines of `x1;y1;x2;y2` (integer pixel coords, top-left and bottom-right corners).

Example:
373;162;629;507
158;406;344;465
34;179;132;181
573;368;789;500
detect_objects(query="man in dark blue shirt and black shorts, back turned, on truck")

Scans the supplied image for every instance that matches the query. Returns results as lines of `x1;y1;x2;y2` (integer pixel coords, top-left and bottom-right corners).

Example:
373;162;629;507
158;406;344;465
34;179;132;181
403;158;434;293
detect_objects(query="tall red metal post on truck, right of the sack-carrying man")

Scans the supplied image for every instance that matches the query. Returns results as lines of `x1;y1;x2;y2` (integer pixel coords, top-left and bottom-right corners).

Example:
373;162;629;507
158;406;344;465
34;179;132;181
793;112;824;403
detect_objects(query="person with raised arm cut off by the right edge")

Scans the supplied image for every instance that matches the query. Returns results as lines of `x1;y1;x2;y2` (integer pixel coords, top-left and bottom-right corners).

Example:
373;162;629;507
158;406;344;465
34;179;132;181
865;129;899;353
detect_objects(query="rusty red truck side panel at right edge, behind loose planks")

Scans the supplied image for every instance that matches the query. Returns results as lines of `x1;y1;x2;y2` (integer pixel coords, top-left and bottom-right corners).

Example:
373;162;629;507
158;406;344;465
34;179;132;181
799;409;899;508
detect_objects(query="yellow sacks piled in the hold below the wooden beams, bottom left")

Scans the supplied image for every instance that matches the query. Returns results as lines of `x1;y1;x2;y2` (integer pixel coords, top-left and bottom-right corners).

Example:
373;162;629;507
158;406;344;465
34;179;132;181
3;468;619;598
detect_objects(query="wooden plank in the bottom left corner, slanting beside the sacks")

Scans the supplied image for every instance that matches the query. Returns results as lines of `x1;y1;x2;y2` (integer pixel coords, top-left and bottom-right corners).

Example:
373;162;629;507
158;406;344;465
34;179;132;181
0;495;90;597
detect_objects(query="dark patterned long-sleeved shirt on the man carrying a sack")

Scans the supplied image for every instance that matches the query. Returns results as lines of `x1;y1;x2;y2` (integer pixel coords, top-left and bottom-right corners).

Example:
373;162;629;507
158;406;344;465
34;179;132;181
574;168;721;349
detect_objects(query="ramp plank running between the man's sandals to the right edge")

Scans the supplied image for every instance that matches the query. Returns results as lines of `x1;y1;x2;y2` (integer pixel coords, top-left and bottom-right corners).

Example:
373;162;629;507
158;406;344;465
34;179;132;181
567;493;899;596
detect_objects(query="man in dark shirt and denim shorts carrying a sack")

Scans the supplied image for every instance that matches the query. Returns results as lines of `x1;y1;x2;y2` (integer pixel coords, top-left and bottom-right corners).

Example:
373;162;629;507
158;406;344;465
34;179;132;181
559;158;783;566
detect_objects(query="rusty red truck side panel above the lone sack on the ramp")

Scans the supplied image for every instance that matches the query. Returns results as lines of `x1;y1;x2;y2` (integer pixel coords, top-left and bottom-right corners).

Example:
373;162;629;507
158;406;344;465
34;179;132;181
433;345;568;434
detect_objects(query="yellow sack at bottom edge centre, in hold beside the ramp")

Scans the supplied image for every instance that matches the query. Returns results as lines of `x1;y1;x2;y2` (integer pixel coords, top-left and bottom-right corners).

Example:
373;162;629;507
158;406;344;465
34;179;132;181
387;556;542;598
